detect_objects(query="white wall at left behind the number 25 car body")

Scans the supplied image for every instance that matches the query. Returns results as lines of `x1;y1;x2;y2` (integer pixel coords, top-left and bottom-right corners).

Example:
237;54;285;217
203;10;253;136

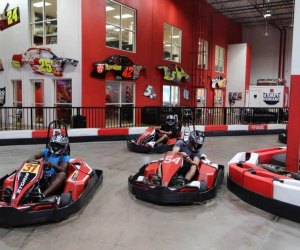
0;0;82;107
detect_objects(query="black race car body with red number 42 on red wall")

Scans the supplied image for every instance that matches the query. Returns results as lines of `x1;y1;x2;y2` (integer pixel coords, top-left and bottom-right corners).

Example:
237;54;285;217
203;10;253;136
91;55;144;80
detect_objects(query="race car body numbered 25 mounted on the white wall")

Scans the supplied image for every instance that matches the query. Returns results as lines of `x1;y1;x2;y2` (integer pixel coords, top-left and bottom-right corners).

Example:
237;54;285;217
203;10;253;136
11;48;78;77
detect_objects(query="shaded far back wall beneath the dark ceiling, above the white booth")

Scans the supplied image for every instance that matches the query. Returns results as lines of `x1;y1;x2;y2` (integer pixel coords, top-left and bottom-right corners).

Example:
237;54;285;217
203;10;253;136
243;25;293;86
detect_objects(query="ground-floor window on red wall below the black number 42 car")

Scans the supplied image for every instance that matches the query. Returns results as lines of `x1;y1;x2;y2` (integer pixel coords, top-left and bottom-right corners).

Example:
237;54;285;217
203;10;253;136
105;81;135;127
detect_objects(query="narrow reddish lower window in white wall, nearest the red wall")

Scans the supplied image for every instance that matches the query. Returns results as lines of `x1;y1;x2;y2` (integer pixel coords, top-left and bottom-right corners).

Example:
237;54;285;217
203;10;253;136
54;80;72;124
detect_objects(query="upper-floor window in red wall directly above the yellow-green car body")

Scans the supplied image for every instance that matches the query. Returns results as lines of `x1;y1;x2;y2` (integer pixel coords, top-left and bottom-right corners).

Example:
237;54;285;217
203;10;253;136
163;23;181;62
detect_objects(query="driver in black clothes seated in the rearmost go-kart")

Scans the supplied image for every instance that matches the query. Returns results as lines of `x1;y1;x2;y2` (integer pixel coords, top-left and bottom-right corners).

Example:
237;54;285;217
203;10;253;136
150;115;179;147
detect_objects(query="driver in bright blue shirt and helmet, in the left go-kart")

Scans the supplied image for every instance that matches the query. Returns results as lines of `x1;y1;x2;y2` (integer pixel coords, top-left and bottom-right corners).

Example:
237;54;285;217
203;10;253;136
33;132;70;197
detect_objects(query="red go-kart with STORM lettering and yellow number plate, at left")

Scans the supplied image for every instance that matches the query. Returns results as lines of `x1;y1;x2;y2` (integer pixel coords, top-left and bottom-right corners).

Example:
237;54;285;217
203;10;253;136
0;121;103;227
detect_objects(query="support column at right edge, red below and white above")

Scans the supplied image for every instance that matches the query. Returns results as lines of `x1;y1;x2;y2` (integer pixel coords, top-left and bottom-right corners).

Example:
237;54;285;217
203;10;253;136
286;1;300;172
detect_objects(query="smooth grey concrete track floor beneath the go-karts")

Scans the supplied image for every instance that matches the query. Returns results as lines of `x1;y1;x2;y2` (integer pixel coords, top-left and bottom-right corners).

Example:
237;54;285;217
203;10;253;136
0;135;300;250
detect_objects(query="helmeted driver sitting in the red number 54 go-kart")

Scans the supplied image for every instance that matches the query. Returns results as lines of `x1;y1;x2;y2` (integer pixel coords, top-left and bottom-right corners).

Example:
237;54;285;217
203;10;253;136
173;130;205;185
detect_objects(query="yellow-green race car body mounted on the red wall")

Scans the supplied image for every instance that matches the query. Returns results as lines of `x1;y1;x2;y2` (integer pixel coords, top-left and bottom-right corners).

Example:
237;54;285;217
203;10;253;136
157;63;190;83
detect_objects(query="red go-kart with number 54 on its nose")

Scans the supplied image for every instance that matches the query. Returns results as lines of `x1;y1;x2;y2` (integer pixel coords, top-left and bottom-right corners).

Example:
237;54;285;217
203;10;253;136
128;152;224;205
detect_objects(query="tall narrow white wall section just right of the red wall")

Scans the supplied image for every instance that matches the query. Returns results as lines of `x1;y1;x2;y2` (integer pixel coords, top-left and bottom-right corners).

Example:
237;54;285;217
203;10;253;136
226;43;247;107
